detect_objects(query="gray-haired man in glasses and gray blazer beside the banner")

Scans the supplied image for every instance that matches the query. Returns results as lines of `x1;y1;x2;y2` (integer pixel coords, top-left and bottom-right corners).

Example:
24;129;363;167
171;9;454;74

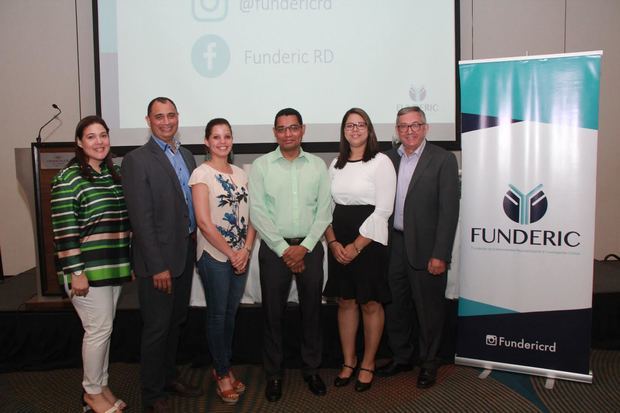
377;106;459;388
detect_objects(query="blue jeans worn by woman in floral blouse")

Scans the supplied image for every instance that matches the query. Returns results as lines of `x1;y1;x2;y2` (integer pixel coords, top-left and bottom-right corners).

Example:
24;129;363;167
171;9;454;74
198;251;248;377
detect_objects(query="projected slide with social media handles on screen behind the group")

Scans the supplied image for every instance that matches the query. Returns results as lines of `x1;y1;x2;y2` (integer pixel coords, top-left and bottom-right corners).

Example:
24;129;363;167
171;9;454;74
97;0;456;145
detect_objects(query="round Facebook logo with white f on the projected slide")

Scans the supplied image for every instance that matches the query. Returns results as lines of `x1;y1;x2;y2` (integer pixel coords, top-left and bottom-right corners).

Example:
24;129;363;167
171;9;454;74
192;34;230;78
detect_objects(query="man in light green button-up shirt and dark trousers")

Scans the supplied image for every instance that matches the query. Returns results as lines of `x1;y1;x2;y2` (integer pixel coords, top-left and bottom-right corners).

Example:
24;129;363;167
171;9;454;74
249;108;331;402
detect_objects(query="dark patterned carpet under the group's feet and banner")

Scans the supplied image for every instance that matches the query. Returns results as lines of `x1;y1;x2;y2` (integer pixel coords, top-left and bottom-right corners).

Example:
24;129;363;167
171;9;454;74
0;350;620;413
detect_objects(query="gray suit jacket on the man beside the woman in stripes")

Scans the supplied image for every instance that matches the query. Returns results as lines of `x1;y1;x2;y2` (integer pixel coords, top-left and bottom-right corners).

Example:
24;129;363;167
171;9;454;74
121;138;196;277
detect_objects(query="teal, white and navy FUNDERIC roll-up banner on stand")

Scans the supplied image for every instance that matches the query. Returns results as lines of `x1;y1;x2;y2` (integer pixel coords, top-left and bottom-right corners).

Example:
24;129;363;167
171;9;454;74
456;51;602;383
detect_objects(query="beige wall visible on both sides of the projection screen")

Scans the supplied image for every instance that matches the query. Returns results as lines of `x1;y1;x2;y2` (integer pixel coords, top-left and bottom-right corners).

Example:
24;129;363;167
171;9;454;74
0;0;620;274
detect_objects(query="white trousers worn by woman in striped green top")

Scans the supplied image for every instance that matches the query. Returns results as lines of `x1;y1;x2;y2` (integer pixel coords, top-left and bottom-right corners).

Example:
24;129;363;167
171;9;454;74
71;285;122;394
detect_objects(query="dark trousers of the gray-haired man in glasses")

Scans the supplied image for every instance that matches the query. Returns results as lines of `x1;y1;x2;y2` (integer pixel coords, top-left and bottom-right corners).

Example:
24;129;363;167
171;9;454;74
385;231;447;368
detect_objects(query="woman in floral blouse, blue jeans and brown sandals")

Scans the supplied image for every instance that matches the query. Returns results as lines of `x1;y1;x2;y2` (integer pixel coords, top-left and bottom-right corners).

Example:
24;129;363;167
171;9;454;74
189;118;256;404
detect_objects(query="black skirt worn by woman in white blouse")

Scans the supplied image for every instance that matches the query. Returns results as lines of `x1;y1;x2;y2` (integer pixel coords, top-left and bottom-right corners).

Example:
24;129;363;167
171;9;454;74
323;204;391;304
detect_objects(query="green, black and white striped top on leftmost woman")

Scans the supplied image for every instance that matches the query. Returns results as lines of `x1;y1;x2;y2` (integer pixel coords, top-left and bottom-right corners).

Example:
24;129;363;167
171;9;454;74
51;164;131;287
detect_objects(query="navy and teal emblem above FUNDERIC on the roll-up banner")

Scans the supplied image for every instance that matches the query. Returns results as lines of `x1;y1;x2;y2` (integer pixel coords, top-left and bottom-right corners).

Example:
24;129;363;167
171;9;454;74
504;184;547;225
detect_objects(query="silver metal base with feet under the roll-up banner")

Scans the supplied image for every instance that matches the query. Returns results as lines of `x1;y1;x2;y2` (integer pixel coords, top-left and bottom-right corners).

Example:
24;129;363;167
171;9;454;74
454;356;592;388
